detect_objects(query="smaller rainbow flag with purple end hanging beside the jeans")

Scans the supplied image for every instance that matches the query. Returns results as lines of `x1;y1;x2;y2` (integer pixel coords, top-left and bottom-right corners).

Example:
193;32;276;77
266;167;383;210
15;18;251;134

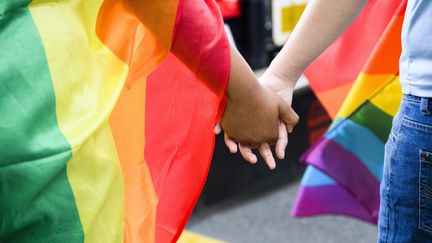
292;0;406;223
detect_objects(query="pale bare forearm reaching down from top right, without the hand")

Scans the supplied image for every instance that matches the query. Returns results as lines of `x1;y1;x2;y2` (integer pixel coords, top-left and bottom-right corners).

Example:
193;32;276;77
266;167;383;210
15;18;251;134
267;0;367;86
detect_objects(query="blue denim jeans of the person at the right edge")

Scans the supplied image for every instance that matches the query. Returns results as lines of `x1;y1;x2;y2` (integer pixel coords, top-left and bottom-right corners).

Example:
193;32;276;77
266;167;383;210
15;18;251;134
378;95;432;243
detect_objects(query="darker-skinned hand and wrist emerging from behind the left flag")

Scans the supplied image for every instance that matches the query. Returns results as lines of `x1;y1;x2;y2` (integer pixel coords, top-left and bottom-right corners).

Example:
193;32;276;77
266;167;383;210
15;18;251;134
221;45;298;147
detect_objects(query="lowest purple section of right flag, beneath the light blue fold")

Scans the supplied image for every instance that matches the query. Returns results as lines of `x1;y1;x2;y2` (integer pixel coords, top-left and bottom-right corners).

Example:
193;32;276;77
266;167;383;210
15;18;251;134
291;185;378;224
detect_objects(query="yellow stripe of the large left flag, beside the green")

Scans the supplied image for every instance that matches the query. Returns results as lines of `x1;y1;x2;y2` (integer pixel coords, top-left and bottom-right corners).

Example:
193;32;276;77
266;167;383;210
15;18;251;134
29;0;128;243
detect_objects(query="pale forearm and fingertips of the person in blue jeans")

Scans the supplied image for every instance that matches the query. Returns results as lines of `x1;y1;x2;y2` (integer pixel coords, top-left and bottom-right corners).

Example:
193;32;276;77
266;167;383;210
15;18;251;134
221;0;367;169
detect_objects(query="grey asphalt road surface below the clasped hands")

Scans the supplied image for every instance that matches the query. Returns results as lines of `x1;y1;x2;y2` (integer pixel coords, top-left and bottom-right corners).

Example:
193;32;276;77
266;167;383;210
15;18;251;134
187;182;376;243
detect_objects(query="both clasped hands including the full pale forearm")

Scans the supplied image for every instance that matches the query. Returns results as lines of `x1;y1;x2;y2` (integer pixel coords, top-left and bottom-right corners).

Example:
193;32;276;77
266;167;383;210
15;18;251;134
215;0;366;169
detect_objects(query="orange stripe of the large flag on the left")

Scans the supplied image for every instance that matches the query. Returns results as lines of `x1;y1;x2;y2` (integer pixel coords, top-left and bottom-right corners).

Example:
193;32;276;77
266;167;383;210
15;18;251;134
97;1;178;242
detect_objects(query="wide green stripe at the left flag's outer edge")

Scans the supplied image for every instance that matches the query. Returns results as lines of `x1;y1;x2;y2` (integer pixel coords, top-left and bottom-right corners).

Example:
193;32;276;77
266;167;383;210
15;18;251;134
0;4;84;242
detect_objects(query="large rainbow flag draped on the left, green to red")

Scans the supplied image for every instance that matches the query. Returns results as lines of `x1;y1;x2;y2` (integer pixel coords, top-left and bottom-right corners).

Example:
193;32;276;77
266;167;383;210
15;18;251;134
0;0;230;243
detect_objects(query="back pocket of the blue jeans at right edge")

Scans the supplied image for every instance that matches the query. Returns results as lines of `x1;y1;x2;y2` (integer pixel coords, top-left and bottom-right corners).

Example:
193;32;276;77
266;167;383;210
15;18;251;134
419;150;432;234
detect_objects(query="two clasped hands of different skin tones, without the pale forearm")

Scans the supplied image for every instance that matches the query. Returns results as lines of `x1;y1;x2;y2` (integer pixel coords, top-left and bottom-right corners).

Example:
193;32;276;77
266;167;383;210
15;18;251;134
215;48;299;169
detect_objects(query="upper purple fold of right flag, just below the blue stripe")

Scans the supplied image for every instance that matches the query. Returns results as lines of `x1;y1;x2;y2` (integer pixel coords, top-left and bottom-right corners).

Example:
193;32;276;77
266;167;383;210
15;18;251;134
302;138;379;218
